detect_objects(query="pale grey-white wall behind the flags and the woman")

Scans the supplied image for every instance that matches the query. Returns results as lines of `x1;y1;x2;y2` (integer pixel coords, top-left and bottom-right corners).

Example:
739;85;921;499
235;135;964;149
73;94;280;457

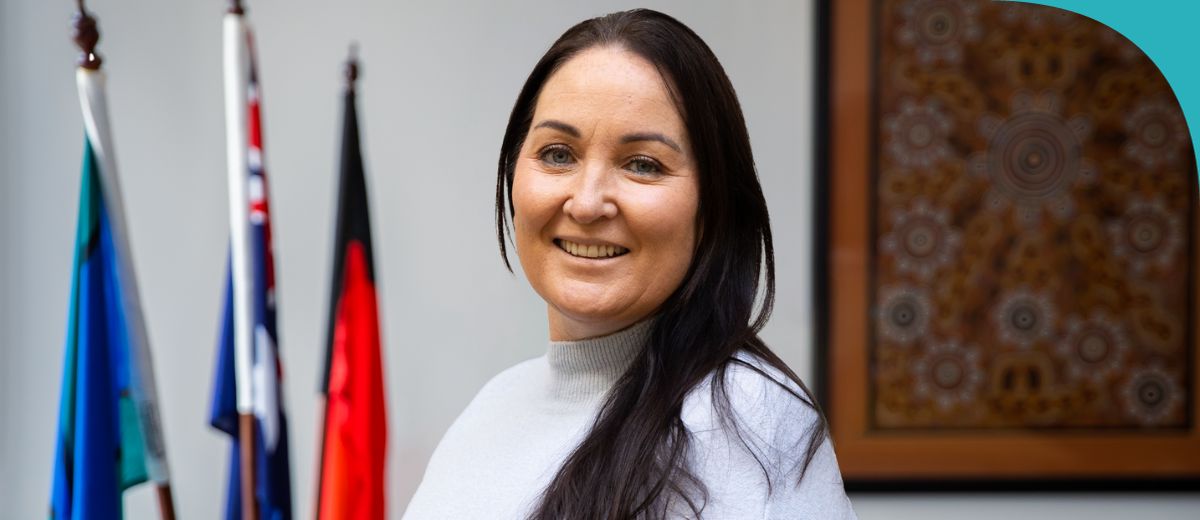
0;0;1200;519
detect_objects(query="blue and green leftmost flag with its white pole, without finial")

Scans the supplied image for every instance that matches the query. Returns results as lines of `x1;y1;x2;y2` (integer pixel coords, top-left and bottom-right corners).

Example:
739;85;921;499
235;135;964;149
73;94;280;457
49;68;168;519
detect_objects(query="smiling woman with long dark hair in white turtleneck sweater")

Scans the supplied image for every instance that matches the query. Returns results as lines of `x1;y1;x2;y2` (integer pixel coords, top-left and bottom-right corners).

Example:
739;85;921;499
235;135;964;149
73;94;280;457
406;10;854;519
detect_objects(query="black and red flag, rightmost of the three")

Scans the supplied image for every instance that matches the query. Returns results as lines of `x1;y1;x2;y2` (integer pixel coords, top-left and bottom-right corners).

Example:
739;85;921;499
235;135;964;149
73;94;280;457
317;65;388;520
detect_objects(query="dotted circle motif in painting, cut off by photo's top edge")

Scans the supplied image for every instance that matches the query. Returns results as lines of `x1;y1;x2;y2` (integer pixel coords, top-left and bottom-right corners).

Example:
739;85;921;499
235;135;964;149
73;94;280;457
896;0;983;65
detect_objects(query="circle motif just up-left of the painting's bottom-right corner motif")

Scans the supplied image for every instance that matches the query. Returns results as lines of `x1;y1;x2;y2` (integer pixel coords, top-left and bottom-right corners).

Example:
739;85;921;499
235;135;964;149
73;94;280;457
1055;311;1129;382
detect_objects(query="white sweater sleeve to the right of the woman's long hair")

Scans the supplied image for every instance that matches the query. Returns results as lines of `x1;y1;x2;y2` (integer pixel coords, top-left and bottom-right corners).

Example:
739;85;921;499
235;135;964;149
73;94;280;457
684;355;857;520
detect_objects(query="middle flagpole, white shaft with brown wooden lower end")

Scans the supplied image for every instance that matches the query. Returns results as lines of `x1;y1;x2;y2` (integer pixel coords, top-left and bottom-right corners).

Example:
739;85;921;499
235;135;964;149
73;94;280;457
224;0;258;520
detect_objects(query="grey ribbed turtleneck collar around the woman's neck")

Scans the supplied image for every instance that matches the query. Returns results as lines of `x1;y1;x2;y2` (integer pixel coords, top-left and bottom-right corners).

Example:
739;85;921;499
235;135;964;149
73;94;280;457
546;318;654;401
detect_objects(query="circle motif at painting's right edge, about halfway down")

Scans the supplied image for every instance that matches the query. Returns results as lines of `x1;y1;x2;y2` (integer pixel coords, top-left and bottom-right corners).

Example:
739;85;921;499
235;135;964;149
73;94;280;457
1108;197;1183;274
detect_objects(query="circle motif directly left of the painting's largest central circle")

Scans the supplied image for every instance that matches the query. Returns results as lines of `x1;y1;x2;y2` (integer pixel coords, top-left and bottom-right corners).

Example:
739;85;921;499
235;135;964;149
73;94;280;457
883;98;954;169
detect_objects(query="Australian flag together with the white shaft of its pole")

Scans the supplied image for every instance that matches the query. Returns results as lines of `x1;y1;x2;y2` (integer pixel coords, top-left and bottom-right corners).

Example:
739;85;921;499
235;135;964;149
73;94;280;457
209;14;292;520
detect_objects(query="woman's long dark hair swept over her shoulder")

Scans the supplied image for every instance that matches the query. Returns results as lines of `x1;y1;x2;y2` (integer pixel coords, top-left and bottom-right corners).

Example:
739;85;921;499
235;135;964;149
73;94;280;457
496;10;827;520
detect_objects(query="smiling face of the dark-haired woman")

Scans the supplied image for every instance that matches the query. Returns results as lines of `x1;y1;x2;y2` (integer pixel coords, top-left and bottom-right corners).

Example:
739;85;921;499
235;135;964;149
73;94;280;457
512;47;700;340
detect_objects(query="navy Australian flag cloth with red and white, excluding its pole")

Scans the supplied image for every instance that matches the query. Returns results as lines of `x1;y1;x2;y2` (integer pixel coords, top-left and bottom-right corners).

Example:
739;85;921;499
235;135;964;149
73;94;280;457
209;36;292;520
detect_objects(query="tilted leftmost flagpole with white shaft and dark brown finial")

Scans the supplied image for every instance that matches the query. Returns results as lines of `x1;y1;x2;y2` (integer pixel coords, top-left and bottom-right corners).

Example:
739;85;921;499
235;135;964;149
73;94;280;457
72;0;175;520
